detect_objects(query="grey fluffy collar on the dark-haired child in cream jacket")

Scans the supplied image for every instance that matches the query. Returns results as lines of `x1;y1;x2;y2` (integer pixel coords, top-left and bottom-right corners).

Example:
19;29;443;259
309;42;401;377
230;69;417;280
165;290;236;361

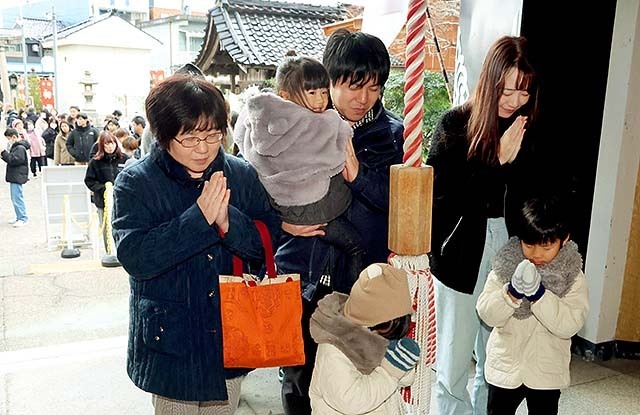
493;237;582;320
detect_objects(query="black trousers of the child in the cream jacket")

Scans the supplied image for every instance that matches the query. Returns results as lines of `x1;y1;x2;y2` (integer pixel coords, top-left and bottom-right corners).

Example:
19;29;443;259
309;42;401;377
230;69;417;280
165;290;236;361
487;384;560;415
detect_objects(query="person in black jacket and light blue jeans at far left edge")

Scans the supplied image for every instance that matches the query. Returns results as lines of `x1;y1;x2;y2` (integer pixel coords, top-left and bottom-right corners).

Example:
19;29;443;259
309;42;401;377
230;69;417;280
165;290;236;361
0;128;30;228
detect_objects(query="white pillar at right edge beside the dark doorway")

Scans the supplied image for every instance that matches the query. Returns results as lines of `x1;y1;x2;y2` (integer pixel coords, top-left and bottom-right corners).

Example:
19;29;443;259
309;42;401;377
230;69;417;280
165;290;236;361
584;0;640;344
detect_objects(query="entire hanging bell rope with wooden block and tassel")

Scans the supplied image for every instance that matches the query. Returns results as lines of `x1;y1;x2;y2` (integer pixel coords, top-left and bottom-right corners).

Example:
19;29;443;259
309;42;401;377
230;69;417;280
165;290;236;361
389;0;436;415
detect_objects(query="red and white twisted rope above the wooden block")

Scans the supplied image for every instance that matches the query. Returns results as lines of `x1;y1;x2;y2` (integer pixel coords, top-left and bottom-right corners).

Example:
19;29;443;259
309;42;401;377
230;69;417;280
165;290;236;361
403;0;427;167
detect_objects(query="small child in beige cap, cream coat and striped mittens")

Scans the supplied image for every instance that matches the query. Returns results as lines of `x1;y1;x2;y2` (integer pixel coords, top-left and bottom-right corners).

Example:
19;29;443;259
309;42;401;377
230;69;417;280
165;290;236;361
309;264;420;415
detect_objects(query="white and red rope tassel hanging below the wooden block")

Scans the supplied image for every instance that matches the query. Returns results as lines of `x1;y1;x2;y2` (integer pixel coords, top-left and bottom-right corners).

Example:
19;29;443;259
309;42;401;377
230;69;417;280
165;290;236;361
389;254;436;415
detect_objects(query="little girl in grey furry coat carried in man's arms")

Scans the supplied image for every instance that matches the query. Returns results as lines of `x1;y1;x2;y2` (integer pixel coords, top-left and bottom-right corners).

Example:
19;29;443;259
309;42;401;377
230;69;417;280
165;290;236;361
233;56;363;286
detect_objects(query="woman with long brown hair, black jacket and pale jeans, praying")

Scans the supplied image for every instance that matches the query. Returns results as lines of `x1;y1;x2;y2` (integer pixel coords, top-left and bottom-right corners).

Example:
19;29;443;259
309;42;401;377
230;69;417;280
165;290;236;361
427;36;537;415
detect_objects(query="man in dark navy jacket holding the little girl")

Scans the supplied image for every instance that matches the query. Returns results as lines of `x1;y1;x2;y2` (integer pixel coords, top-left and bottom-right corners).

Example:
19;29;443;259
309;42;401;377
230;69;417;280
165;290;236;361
276;30;404;415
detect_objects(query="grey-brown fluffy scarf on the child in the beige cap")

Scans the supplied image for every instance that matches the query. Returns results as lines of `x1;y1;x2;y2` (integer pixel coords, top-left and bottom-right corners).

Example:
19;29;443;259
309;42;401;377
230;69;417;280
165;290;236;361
309;292;389;375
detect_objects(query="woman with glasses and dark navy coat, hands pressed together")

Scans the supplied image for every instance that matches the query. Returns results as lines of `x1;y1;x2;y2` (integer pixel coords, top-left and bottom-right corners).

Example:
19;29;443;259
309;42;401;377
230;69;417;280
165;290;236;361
113;74;280;414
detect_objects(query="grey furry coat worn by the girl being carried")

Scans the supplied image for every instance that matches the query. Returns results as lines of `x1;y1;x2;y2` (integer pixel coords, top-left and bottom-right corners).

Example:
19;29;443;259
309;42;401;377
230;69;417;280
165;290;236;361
233;92;353;206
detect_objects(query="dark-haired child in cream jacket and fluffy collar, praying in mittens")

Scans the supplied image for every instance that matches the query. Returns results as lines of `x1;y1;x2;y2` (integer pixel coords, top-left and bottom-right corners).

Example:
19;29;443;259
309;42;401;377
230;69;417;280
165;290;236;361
476;197;589;415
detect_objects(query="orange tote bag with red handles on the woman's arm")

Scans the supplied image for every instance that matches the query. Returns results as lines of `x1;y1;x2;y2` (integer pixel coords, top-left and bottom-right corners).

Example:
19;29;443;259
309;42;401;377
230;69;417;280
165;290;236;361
220;221;304;368
